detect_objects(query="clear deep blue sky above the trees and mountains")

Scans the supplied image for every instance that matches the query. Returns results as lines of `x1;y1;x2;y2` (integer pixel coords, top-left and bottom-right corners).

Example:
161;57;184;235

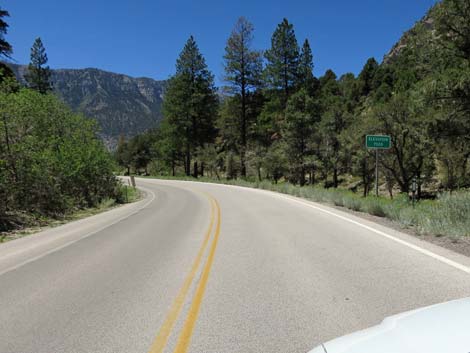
1;0;436;84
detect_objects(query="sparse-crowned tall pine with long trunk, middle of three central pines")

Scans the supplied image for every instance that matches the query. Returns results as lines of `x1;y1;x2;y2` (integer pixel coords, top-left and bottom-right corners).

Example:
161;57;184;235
224;17;262;177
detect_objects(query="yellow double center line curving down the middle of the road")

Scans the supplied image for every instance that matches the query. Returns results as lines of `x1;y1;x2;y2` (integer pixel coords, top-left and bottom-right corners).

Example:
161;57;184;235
149;194;220;353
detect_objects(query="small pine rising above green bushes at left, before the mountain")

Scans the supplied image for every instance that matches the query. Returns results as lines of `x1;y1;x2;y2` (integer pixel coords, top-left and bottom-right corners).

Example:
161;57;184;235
25;37;52;94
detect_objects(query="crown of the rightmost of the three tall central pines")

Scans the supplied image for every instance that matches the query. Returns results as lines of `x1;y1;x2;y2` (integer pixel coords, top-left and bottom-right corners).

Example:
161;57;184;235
265;19;299;107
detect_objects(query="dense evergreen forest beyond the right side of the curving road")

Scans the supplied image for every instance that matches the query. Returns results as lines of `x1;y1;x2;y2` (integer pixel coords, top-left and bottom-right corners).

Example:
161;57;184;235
116;0;470;195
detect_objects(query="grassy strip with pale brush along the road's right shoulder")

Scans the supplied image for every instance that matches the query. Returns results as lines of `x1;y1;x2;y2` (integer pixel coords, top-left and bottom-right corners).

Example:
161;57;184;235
142;176;470;237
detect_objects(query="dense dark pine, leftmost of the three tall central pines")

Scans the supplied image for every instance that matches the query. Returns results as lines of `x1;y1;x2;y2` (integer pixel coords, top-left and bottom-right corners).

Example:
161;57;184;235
163;36;218;177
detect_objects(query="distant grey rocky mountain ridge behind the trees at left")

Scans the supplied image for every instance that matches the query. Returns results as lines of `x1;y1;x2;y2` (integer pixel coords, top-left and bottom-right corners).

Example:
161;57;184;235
8;63;166;148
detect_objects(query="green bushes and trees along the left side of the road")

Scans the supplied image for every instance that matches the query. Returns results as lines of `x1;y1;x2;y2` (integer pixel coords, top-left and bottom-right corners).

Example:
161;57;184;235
0;9;122;233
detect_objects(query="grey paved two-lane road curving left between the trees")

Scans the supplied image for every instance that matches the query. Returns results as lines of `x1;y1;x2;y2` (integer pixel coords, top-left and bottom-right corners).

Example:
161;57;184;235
0;179;470;353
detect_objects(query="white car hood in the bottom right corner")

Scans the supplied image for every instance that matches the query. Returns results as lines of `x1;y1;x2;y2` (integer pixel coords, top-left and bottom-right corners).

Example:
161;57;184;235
312;298;470;353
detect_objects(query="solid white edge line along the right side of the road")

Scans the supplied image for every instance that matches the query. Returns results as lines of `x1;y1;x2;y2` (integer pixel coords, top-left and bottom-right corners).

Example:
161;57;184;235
153;179;470;274
